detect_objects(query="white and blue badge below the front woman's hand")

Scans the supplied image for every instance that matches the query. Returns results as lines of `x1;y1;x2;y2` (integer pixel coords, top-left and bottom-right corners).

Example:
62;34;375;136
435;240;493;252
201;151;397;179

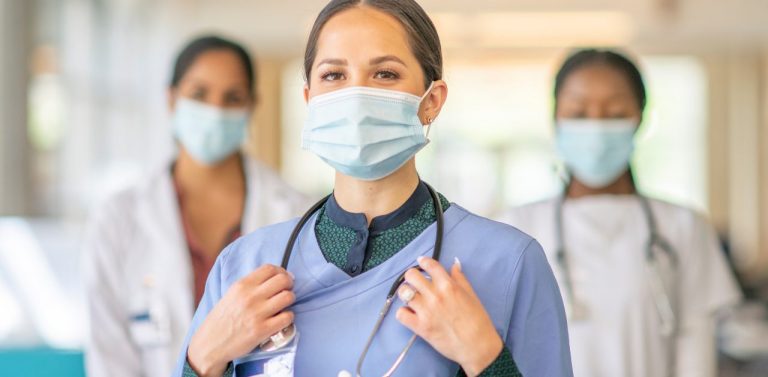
235;325;299;377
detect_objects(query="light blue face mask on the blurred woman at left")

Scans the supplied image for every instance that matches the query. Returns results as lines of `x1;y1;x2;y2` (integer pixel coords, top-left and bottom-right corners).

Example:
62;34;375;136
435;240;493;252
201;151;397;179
173;98;249;165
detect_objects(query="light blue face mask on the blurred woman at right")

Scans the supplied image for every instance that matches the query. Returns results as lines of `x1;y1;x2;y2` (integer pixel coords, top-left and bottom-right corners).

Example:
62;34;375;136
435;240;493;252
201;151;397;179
556;119;637;188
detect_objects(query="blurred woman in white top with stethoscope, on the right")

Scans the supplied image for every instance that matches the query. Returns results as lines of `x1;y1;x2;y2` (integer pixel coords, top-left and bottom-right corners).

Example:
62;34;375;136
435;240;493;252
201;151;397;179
501;50;740;377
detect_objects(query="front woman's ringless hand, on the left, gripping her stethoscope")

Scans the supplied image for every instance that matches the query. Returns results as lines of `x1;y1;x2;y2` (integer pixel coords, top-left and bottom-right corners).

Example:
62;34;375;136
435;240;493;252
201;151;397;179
187;264;295;376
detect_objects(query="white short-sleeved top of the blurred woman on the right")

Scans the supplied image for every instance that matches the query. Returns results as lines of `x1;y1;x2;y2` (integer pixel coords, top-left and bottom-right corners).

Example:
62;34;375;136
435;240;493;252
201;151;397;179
499;195;740;377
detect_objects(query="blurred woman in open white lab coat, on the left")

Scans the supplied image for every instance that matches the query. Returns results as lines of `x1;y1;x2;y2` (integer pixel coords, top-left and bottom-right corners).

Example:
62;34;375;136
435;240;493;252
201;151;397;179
85;36;307;377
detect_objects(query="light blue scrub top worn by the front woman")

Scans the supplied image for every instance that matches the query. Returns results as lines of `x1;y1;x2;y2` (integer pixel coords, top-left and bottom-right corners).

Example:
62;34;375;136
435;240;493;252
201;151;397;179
174;204;573;377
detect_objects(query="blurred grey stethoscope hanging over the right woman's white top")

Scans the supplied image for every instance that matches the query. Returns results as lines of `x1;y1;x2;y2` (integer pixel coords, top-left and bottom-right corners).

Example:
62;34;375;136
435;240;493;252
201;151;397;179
555;190;678;337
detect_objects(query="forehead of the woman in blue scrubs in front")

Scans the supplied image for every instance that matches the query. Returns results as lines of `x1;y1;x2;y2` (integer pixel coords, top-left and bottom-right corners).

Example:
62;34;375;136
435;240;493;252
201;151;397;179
317;6;409;57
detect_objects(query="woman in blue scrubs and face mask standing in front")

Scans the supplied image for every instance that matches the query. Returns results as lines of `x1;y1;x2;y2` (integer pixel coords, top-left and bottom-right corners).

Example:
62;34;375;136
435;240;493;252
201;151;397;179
175;0;572;376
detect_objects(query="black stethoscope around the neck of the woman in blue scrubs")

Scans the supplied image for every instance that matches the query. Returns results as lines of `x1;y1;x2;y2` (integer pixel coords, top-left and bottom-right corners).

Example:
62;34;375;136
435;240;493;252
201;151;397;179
259;183;443;377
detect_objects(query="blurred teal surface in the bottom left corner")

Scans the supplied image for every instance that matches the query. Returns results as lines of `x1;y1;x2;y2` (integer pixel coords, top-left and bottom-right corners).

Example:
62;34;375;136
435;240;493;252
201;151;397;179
0;347;85;377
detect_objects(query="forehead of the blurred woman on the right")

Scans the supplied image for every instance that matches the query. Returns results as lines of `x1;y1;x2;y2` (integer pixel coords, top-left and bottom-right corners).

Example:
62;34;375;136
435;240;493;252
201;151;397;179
558;63;637;101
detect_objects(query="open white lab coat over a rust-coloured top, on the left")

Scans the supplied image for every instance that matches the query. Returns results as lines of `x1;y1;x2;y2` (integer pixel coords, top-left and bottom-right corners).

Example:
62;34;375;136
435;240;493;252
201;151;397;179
84;158;311;377
